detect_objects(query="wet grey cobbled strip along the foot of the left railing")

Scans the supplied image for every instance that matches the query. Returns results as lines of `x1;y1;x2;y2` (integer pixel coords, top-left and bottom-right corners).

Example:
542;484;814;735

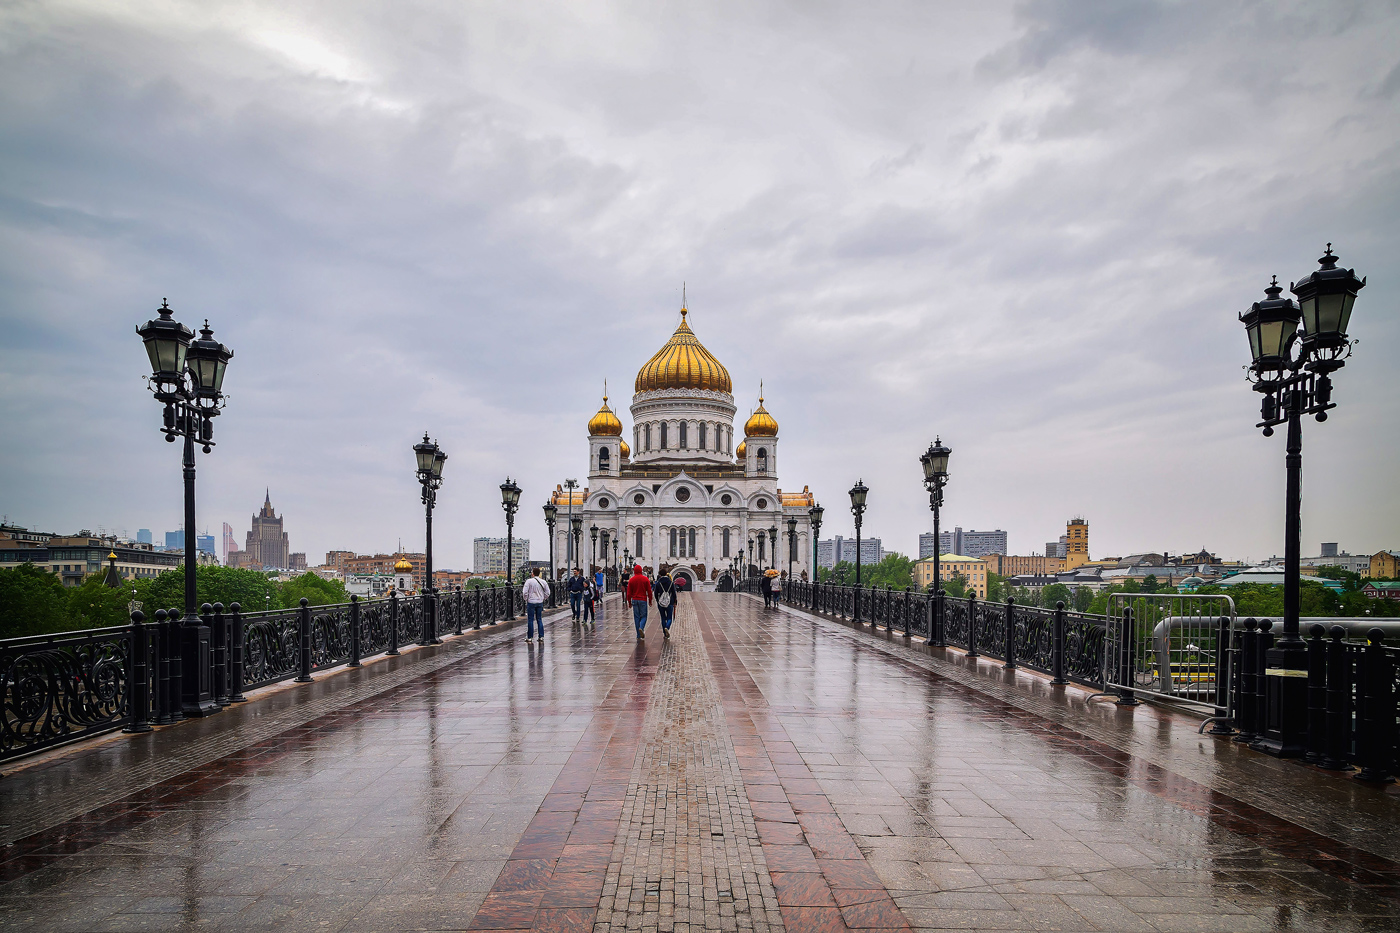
0;599;579;846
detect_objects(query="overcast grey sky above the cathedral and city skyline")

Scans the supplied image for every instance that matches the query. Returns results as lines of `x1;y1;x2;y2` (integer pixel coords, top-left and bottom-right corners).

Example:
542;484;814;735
0;0;1400;569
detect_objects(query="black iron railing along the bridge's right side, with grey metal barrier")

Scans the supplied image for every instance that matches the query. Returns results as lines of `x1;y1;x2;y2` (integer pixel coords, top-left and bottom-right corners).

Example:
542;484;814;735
736;579;1400;780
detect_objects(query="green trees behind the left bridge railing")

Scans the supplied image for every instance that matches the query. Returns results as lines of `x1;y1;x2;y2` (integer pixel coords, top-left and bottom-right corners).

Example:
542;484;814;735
0;563;350;639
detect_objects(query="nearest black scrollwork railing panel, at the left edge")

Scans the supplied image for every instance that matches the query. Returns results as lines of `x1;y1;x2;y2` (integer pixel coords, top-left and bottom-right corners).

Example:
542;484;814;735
0;626;132;759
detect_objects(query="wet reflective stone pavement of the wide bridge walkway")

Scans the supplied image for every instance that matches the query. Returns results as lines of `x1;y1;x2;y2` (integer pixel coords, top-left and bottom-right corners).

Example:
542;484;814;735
0;594;1400;933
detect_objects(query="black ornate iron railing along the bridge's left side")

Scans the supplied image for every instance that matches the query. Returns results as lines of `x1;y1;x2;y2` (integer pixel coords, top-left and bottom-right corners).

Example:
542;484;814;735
0;584;546;761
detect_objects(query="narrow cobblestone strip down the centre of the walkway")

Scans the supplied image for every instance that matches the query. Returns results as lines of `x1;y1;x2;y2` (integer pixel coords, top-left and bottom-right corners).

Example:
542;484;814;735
594;598;784;933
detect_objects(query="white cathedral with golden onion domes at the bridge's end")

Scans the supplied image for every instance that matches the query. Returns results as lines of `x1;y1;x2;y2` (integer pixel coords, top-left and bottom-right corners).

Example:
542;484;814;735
552;307;815;591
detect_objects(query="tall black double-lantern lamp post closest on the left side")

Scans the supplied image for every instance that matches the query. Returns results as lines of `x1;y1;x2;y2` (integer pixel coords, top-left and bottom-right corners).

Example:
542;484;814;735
136;300;234;721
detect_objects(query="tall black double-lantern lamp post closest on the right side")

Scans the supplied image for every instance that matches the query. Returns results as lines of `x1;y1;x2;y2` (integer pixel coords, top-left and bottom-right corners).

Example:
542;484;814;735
1239;244;1366;758
